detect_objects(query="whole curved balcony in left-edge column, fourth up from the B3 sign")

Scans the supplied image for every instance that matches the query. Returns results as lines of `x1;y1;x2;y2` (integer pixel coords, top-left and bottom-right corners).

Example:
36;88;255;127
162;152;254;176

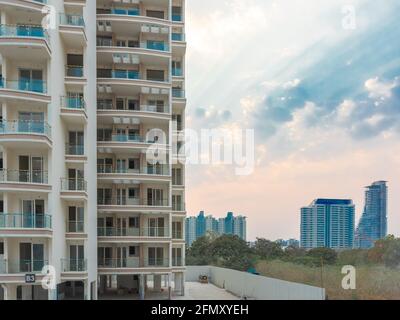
0;120;52;148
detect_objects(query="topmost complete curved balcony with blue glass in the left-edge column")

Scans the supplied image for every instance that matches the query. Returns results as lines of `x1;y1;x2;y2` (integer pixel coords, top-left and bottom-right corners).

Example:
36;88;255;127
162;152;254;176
0;24;51;62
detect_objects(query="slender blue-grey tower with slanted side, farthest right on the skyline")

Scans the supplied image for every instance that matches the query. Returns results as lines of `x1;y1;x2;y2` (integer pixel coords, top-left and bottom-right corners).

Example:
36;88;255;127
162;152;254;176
355;181;387;249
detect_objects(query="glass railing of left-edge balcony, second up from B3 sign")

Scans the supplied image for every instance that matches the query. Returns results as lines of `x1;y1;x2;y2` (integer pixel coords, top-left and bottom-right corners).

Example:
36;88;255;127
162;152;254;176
0;213;51;229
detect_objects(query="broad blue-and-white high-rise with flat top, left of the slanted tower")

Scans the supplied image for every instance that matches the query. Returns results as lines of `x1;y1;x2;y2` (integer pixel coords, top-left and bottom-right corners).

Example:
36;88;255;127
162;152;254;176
300;199;355;249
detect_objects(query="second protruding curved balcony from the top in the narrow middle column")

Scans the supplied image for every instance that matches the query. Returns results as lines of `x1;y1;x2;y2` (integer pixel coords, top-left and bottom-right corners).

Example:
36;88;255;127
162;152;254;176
61;96;88;124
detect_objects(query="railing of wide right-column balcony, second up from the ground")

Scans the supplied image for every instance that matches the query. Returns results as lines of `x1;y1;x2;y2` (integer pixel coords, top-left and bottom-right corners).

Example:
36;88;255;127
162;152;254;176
97;227;169;238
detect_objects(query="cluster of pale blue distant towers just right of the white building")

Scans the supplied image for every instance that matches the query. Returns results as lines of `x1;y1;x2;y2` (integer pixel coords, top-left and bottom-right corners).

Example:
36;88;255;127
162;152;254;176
186;211;247;246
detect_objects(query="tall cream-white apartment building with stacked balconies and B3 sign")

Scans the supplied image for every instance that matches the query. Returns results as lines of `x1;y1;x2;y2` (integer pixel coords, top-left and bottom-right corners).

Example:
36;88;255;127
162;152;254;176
0;0;186;300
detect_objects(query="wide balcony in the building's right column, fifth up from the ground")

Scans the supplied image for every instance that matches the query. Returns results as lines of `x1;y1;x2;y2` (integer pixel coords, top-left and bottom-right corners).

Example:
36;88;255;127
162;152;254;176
97;134;170;153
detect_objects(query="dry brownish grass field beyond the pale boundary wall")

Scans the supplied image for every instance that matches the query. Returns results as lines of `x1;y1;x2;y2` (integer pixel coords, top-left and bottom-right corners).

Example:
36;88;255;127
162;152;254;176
257;260;400;300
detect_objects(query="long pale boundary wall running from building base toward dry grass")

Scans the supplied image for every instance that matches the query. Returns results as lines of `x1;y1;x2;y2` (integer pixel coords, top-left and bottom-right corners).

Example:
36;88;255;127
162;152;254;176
186;266;325;300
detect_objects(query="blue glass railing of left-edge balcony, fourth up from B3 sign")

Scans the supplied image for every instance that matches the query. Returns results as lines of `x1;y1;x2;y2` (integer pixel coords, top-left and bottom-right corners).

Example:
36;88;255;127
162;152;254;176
0;120;51;139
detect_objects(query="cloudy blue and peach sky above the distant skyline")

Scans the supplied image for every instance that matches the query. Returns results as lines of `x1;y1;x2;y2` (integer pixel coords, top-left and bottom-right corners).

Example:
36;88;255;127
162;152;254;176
186;0;400;239
